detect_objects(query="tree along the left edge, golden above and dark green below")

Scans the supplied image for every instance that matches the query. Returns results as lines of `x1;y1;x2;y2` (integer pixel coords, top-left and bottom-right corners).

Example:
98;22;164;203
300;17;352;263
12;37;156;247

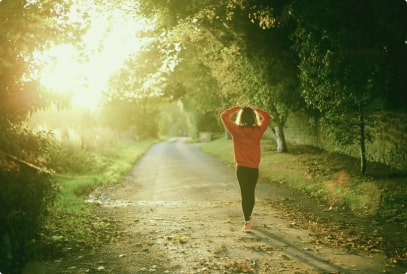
0;0;88;273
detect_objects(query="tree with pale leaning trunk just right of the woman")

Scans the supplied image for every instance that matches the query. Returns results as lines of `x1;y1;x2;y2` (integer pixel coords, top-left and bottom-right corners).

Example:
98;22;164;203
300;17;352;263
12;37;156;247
236;6;304;152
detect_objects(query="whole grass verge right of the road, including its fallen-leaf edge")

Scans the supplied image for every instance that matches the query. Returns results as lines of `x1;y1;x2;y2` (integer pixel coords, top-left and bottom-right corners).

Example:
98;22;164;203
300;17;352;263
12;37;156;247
202;139;407;265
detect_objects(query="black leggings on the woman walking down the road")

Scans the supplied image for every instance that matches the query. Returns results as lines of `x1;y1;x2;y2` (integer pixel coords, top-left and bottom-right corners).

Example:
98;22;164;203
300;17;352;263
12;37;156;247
236;166;259;221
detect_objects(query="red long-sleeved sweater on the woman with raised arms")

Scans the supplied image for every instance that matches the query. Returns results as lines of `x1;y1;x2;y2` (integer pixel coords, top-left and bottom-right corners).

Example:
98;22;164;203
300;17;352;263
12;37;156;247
220;106;271;168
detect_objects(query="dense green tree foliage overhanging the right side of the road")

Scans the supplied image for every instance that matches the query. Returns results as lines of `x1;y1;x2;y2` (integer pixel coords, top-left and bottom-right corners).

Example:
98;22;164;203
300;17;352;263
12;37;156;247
135;0;406;155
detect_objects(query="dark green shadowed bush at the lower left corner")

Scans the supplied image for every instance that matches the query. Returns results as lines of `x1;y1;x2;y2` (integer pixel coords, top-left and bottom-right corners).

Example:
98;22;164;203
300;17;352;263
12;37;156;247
0;166;56;273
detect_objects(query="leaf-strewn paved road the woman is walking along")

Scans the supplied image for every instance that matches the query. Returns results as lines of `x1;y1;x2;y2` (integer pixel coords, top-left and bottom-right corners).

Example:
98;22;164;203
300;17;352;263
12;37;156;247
99;139;404;273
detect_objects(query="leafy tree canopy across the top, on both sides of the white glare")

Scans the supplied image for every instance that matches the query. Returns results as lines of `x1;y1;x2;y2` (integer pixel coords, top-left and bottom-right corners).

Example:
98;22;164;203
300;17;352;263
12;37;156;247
0;0;406;169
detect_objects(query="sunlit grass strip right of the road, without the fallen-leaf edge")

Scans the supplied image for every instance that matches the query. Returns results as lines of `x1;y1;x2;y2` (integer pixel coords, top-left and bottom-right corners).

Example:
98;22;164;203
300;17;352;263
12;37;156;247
202;138;407;222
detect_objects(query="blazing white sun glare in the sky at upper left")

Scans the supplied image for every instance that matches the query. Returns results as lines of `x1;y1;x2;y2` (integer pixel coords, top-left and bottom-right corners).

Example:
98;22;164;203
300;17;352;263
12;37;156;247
40;4;151;109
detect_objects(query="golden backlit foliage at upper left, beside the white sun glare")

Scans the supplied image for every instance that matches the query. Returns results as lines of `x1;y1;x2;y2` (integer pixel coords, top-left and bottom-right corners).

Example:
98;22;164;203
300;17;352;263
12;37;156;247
0;0;87;127
